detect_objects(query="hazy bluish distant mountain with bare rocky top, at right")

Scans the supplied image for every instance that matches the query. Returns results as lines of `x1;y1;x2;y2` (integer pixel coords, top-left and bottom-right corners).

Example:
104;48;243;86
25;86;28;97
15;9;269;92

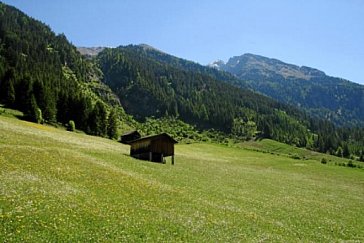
209;54;364;126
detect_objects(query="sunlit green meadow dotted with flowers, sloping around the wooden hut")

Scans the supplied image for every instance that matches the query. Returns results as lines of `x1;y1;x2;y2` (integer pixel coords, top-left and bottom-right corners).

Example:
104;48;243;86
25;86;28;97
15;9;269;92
0;116;364;242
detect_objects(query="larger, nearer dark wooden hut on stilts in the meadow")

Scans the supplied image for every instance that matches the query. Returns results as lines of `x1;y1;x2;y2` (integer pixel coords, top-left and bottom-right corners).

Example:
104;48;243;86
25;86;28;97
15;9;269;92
128;133;177;165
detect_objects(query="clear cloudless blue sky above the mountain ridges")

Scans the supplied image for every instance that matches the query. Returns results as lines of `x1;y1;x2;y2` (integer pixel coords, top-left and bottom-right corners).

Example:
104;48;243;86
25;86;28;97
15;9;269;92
3;0;364;84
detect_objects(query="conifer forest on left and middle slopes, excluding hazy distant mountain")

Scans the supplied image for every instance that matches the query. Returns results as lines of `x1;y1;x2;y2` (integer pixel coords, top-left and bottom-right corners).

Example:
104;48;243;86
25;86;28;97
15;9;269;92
0;4;364;161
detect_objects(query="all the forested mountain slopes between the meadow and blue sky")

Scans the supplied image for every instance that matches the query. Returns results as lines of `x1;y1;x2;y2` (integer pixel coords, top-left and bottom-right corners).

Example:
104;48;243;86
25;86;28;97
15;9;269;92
0;4;364;157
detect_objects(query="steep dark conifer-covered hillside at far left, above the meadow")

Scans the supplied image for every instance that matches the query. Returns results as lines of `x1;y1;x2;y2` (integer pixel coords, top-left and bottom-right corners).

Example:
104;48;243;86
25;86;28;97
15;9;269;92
0;3;121;136
